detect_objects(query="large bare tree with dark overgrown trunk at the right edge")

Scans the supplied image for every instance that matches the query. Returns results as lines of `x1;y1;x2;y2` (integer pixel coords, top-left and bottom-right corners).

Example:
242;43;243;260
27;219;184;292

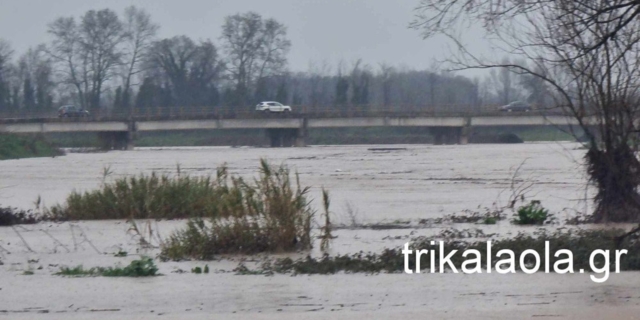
413;0;640;221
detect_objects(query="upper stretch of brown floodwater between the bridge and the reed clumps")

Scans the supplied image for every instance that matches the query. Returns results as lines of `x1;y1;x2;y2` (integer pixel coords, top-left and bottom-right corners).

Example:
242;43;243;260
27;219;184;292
0;143;589;223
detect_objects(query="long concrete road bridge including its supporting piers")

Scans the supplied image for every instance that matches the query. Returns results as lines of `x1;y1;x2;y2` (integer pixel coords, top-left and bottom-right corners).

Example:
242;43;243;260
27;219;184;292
0;112;578;149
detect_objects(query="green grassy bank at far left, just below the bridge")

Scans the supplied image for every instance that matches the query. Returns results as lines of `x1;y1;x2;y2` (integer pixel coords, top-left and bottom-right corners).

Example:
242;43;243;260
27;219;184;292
0;134;64;160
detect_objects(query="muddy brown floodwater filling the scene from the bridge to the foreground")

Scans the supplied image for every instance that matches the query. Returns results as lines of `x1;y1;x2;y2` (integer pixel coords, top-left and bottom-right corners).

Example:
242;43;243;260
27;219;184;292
0;143;640;319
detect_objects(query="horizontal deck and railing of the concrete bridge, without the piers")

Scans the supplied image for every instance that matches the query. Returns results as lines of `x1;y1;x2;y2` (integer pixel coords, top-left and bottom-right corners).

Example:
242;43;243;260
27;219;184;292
0;112;592;133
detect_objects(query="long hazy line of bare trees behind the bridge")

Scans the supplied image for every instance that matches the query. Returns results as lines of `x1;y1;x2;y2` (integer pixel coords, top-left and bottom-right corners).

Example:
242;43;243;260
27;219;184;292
0;6;546;113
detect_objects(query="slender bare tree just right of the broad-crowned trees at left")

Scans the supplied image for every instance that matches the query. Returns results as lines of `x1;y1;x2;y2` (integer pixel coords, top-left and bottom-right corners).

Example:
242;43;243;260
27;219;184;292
122;6;159;108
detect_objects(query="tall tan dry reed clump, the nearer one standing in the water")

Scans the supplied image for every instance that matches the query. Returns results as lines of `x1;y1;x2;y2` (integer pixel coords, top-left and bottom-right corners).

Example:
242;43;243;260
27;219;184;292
161;160;314;260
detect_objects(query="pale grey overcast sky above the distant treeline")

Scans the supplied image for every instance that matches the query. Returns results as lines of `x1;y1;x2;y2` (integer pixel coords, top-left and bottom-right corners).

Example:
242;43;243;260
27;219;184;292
0;0;490;76
